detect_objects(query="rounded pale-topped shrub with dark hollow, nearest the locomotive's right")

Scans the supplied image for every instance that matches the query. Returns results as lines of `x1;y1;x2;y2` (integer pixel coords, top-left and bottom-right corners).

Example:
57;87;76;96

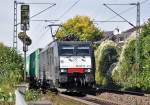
95;40;119;86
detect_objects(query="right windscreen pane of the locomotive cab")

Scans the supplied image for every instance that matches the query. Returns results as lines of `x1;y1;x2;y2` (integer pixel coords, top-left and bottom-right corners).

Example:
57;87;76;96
76;46;90;55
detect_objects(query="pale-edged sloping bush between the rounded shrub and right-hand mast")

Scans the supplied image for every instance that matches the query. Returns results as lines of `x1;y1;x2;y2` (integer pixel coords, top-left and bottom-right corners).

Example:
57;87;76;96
113;34;135;87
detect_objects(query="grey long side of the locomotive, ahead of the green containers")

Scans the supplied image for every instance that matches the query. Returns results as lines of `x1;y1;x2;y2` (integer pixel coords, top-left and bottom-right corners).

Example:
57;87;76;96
40;42;58;87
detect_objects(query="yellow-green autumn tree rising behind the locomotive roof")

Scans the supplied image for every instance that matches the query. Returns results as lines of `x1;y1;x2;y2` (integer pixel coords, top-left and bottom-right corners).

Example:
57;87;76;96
56;16;103;41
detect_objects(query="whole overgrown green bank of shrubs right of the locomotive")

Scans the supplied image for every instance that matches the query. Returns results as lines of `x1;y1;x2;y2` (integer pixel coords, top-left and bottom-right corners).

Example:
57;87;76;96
95;19;150;93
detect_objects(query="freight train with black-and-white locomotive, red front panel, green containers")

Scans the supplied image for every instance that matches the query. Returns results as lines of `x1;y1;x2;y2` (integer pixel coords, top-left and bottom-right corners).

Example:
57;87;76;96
26;41;95;90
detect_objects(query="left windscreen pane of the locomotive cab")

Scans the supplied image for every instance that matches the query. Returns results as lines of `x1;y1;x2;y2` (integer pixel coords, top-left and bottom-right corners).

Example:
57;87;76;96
60;46;74;55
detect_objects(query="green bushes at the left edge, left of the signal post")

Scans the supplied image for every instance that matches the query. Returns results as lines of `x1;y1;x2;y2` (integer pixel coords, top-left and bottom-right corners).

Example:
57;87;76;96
0;43;23;99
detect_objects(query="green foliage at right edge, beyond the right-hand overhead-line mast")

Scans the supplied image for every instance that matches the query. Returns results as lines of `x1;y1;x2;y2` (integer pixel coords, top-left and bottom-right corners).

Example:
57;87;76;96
139;19;150;92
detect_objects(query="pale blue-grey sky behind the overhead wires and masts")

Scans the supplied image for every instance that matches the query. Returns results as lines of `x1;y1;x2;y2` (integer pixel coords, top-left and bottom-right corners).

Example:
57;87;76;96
0;0;150;54
